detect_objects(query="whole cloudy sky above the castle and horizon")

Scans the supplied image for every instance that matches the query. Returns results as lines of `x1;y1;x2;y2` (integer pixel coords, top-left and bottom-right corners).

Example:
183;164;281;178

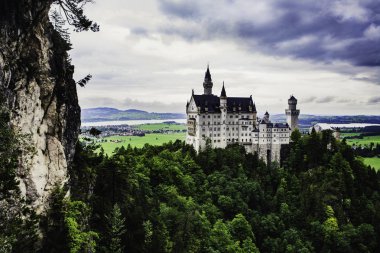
71;0;380;115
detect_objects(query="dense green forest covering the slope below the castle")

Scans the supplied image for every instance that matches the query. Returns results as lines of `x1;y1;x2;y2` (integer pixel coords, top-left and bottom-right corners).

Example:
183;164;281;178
37;131;380;252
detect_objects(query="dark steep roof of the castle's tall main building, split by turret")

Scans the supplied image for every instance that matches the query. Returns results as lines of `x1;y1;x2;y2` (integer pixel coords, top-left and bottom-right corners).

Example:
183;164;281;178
193;95;256;113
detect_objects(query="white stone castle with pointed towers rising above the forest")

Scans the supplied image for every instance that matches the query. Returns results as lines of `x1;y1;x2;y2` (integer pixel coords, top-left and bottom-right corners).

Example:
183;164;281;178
186;67;300;162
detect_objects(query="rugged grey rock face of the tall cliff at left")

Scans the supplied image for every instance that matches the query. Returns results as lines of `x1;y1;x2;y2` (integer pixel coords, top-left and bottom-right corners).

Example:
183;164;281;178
0;0;80;213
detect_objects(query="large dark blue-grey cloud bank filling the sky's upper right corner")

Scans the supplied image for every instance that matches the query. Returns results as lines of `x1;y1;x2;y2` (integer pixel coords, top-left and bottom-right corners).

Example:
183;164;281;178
160;0;380;67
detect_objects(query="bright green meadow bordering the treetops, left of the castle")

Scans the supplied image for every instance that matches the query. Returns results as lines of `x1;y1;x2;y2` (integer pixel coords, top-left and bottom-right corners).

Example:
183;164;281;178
99;133;186;155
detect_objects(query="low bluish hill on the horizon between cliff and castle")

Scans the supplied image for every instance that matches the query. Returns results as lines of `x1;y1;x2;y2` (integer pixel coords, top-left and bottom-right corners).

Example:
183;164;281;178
82;107;186;122
